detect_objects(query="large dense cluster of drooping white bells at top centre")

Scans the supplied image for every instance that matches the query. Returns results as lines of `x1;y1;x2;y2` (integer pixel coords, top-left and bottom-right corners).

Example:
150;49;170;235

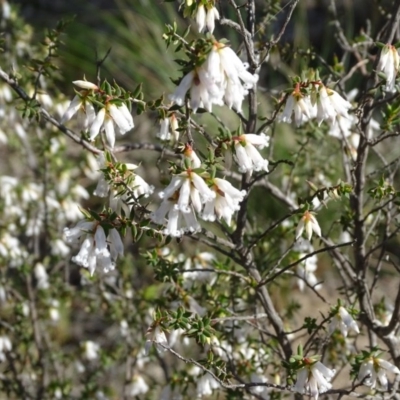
170;42;258;112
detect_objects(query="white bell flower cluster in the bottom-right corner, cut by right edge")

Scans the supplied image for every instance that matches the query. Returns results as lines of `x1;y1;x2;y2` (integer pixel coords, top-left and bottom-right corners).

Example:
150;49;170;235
358;357;400;391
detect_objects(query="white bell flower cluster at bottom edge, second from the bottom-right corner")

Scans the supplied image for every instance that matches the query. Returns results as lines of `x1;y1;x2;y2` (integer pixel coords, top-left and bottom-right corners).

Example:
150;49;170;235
293;361;335;400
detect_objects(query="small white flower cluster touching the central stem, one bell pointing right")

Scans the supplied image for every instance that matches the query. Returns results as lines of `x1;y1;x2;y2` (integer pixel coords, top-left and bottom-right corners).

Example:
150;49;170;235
234;133;269;173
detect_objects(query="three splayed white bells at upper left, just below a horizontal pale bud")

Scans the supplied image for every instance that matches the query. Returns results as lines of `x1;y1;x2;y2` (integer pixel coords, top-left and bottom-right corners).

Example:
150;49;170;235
89;103;134;148
